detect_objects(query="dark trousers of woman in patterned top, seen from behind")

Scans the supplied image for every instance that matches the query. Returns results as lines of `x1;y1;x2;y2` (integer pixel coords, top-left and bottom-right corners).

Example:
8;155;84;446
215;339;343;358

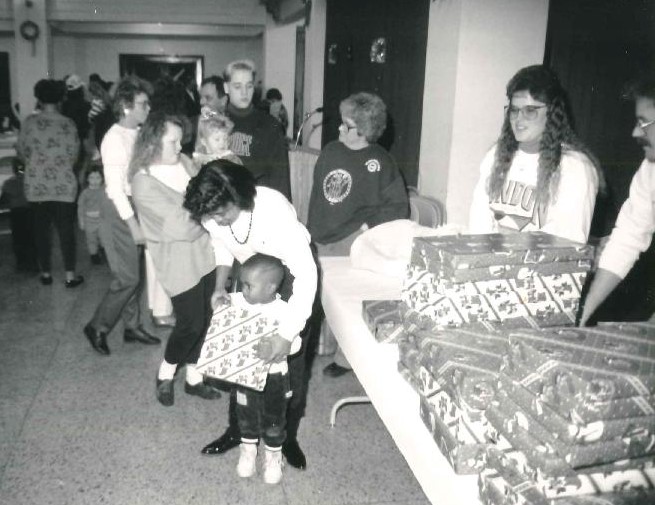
30;202;76;272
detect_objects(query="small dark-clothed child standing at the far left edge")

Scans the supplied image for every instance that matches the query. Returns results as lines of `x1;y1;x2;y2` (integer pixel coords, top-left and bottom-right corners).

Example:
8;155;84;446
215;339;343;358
0;158;39;272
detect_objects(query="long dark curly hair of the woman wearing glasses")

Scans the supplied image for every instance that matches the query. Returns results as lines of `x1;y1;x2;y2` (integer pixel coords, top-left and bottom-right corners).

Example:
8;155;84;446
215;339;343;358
487;65;605;212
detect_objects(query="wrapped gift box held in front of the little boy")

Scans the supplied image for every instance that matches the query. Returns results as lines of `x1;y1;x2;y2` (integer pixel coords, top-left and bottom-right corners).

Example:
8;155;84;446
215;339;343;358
196;305;279;391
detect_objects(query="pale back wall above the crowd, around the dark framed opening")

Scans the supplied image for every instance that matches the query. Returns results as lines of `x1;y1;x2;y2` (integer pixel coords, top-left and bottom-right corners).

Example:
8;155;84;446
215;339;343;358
52;35;263;81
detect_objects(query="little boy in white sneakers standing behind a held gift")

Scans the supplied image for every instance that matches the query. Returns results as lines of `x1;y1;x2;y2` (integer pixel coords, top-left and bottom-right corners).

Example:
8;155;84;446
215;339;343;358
224;254;301;484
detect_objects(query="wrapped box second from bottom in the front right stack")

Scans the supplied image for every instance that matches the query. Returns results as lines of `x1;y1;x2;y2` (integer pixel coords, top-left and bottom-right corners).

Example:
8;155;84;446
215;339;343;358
487;390;655;468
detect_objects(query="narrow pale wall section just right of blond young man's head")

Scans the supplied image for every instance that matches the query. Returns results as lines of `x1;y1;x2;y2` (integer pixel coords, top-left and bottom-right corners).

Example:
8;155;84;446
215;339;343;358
260;20;302;135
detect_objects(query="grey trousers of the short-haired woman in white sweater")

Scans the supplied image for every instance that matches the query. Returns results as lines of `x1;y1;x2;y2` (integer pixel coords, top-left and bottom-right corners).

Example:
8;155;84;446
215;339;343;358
90;200;148;332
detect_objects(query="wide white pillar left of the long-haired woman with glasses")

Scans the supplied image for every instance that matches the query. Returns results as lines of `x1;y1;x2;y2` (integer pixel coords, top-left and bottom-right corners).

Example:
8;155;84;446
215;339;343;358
419;0;549;224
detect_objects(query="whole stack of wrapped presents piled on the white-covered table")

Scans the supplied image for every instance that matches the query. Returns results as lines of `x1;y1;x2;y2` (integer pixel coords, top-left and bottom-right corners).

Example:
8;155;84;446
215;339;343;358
364;232;655;505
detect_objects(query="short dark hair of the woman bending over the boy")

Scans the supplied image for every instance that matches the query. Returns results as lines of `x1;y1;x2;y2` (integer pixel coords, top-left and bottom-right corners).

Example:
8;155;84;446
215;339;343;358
184;159;257;222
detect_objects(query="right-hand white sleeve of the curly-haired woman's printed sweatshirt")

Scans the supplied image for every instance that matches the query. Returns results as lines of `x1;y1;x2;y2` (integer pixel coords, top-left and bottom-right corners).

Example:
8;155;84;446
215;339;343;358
541;152;598;244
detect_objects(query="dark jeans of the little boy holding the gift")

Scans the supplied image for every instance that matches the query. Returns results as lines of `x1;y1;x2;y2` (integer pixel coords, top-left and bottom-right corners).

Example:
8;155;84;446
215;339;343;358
234;373;289;448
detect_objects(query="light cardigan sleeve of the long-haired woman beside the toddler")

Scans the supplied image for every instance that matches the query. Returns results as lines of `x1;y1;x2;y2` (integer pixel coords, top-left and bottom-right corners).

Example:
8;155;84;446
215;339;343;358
132;174;205;242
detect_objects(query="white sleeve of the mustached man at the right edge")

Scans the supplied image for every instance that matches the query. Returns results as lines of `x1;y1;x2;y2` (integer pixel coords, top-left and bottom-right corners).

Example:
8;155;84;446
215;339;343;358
598;160;655;278
